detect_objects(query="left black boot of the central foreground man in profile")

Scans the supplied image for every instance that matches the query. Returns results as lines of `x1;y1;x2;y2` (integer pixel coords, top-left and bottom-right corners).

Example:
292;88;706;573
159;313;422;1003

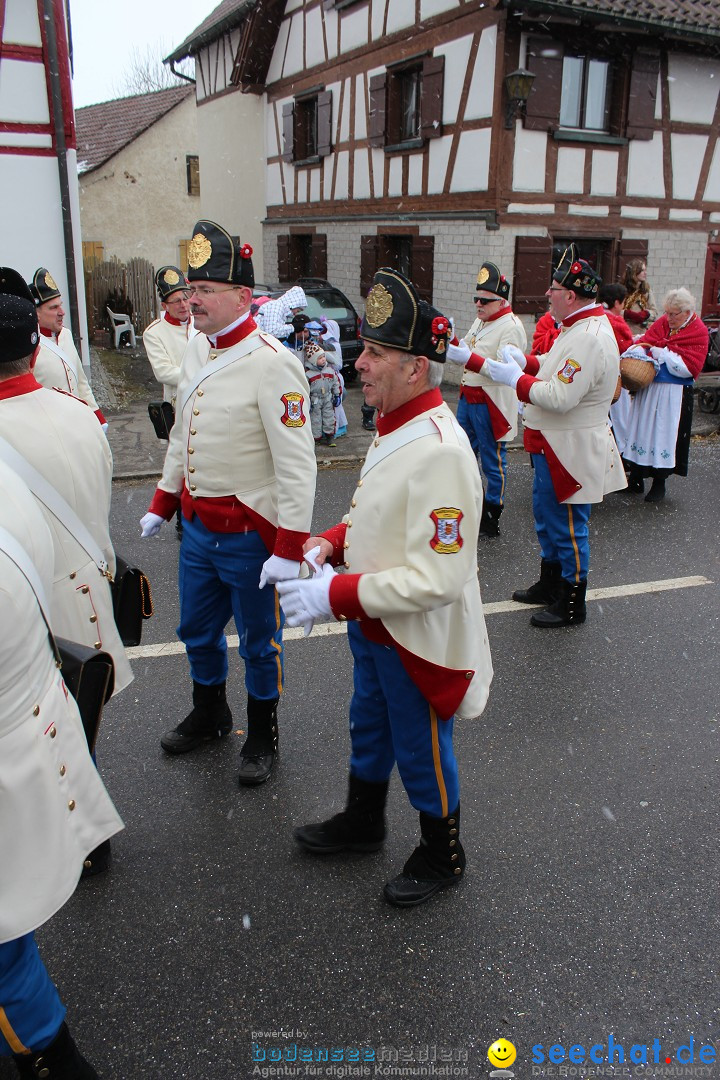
294;773;390;855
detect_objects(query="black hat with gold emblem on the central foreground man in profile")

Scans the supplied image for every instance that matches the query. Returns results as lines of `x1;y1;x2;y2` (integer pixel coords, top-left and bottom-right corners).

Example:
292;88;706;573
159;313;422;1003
361;267;452;364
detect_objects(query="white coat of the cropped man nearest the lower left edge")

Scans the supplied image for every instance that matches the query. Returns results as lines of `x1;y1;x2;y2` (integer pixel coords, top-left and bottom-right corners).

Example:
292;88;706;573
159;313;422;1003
0;468;123;943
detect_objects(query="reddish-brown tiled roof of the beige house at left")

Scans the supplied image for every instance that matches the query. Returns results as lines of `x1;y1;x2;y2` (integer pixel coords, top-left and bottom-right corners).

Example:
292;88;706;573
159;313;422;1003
74;83;193;173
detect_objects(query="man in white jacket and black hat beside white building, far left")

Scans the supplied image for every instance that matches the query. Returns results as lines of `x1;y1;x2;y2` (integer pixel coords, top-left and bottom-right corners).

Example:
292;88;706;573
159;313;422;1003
30;267;108;431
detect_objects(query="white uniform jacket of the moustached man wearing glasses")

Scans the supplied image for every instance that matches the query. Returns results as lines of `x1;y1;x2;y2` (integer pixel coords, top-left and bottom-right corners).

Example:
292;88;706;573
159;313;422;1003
158;328;317;558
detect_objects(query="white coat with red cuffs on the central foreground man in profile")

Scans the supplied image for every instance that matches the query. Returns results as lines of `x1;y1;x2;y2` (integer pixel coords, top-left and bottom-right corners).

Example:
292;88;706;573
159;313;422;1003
328;390;492;718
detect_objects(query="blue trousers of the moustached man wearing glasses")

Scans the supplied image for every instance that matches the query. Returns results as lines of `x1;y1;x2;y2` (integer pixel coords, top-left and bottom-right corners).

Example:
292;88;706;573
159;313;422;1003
177;516;285;700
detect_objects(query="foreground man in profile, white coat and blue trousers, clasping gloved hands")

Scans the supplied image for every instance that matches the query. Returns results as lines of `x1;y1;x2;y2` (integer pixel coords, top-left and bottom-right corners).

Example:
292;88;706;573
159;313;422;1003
277;269;492;906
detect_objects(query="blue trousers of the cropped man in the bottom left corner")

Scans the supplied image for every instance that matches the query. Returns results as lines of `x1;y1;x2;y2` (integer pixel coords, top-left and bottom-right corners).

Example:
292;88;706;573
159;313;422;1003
0;933;65;1055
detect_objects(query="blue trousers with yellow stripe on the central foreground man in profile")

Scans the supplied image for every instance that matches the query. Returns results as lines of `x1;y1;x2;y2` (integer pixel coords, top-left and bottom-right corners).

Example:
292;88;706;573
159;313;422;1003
348;622;460;818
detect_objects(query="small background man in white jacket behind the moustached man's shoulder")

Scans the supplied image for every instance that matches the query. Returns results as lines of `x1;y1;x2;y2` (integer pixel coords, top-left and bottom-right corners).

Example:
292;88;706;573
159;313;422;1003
142;266;196;408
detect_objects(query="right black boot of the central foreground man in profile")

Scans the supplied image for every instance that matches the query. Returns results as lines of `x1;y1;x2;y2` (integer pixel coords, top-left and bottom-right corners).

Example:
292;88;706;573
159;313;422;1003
384;804;465;907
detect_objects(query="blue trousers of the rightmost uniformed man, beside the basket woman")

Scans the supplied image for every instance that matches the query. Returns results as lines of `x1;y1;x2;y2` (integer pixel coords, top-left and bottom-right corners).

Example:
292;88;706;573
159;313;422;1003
531;454;593;582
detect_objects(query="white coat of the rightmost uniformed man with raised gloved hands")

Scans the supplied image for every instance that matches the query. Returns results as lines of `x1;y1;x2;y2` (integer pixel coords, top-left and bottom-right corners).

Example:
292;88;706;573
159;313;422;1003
517;309;627;503
